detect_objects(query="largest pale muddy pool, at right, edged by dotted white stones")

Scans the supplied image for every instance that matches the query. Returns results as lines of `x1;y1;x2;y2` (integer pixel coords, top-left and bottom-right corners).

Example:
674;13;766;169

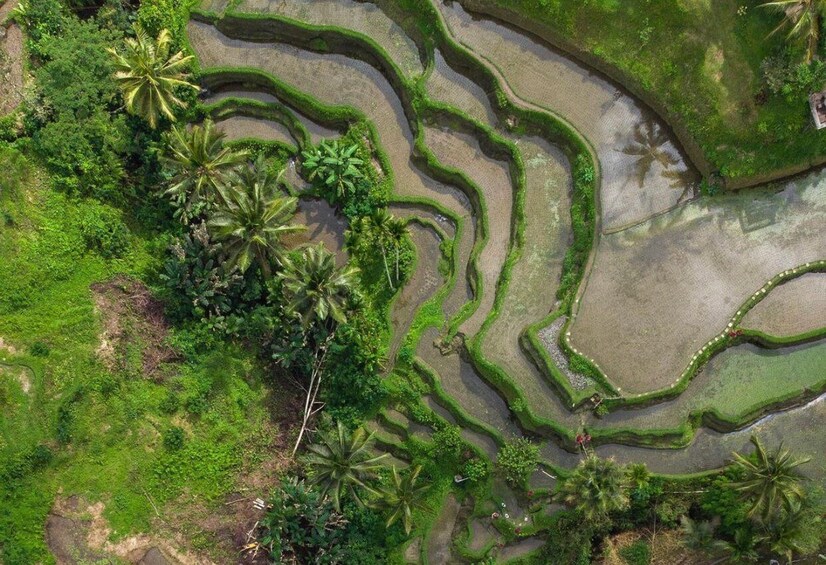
571;170;826;393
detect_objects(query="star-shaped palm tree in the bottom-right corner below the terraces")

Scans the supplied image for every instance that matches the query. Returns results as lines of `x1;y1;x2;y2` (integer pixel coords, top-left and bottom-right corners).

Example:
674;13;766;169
732;436;810;521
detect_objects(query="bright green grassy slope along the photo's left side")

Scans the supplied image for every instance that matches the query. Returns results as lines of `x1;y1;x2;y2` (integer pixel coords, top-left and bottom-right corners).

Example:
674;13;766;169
0;148;275;565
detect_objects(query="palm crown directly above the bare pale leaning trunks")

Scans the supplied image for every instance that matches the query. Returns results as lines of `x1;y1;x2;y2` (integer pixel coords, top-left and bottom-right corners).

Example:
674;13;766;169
278;243;358;328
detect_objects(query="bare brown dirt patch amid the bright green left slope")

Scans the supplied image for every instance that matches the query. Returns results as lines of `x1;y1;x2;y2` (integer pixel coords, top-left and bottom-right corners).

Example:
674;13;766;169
91;276;177;377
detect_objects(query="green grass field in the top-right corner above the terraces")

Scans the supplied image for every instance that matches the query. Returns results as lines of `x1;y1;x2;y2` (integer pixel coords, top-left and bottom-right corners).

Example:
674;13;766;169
483;0;826;180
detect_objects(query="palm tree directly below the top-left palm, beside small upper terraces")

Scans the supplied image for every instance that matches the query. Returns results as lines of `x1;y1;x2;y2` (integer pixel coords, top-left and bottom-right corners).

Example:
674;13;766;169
161;119;248;223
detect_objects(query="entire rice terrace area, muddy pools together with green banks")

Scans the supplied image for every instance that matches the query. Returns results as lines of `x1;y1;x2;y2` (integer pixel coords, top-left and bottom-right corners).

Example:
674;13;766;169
188;0;826;562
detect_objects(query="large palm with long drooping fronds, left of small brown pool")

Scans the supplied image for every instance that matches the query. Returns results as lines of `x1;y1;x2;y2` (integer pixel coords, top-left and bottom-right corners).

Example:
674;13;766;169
208;159;304;277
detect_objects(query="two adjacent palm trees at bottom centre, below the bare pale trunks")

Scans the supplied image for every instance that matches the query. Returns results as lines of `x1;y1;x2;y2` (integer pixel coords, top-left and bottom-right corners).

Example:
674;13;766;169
303;423;429;534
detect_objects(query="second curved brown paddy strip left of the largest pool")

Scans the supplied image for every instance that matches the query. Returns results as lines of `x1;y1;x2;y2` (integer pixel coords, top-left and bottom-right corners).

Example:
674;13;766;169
425;127;515;336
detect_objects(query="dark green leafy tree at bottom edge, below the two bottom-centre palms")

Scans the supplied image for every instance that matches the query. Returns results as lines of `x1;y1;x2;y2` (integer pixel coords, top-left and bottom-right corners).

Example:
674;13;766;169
259;478;347;564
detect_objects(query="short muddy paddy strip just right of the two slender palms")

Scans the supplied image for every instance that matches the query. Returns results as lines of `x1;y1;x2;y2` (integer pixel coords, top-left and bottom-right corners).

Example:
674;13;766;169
387;223;444;367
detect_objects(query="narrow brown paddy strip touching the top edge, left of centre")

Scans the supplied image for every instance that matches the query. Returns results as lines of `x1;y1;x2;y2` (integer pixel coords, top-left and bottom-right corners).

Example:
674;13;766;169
236;0;424;76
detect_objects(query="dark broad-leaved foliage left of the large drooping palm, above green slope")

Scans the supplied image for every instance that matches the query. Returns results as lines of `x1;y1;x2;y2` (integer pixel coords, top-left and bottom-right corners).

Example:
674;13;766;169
160;223;244;328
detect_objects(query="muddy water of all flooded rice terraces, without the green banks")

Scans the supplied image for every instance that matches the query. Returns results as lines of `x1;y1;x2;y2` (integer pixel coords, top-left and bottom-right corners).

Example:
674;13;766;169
188;0;826;490
